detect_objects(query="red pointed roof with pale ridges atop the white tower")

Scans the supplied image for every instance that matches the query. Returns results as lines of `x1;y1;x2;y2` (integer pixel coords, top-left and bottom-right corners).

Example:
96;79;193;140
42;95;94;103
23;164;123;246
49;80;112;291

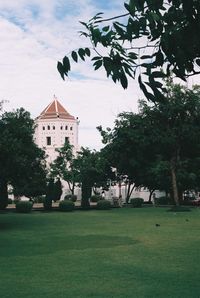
39;96;75;120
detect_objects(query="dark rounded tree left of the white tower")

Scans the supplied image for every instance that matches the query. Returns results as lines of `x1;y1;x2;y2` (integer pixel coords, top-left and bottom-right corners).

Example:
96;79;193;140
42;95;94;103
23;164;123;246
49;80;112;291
0;108;46;208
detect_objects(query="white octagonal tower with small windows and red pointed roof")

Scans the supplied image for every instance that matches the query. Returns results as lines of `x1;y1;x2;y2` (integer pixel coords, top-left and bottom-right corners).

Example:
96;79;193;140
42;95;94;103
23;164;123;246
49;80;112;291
35;96;79;163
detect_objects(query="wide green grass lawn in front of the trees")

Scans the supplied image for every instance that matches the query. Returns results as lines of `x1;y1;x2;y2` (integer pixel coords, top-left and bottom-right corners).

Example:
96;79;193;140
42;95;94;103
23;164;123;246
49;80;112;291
0;208;200;298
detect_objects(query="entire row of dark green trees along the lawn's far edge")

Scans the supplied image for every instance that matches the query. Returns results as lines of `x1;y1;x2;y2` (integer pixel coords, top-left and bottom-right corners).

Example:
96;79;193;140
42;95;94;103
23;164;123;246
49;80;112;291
0;82;200;208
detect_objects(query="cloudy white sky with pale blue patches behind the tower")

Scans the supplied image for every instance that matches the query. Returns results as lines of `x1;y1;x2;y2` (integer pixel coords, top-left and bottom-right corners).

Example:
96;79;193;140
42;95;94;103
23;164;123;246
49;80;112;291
0;0;199;149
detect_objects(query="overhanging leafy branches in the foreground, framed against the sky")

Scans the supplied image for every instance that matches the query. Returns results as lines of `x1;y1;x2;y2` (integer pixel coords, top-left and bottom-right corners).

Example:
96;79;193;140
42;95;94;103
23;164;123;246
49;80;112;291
57;0;200;101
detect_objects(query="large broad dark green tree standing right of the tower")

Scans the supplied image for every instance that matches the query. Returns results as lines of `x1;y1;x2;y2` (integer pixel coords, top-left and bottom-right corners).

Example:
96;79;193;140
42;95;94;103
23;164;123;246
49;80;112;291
100;84;200;205
